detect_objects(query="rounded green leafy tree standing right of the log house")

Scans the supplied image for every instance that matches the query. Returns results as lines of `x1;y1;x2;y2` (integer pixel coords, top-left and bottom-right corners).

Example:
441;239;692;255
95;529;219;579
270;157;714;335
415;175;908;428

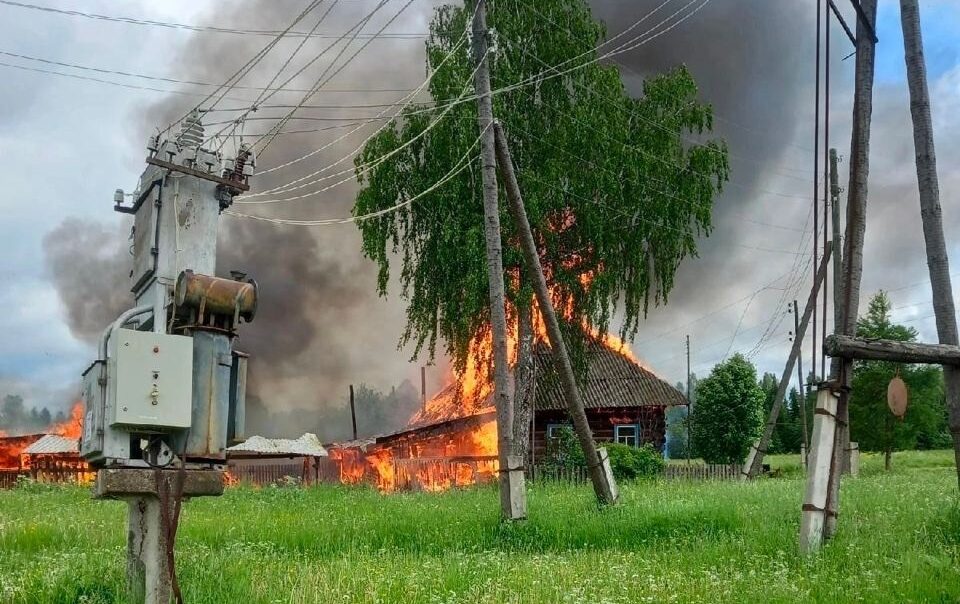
690;354;764;463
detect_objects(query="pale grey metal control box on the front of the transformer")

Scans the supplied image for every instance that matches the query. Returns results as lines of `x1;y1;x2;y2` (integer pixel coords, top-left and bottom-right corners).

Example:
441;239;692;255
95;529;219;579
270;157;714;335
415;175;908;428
107;329;193;429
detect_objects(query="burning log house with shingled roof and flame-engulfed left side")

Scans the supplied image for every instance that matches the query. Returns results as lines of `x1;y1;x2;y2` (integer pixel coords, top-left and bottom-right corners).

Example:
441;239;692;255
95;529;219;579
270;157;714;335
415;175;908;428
328;336;686;491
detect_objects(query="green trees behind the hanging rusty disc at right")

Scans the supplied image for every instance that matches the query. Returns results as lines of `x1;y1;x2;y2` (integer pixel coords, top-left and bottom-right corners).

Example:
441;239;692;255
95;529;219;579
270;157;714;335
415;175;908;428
850;291;951;451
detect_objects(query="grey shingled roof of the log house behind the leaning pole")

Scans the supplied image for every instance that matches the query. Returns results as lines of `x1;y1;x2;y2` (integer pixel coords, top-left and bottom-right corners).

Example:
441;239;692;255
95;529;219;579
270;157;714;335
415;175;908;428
534;340;687;410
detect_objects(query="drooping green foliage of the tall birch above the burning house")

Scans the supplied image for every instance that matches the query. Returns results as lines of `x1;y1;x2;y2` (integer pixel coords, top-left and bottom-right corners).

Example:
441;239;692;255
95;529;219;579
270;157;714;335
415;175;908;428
353;0;729;382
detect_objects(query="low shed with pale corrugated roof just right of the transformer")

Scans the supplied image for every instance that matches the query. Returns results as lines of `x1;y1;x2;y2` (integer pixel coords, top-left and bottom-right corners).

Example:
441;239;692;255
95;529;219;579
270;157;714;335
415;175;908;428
227;432;330;484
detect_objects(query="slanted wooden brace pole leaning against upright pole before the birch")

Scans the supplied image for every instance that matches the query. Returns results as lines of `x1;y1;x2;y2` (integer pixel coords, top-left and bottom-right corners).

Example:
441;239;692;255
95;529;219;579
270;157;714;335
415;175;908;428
494;122;617;505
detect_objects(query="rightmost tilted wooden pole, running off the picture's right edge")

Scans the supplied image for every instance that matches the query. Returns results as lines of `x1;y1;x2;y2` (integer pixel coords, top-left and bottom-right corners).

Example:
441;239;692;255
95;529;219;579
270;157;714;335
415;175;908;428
900;0;960;487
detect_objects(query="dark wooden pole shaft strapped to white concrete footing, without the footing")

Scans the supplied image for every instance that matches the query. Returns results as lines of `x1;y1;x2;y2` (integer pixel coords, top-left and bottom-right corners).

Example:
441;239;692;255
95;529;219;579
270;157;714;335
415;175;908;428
823;0;877;539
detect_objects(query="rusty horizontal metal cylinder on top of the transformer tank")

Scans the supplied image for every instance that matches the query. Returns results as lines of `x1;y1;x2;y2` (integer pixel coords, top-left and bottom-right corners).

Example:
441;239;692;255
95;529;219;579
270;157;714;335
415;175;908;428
174;270;257;323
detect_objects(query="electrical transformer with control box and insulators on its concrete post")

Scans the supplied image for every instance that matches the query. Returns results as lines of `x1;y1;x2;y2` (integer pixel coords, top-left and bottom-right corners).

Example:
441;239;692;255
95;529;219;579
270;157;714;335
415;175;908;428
80;111;257;604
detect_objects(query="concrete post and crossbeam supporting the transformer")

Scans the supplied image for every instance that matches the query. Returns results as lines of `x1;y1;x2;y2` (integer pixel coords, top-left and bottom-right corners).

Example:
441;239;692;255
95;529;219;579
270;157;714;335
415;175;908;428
93;468;223;604
